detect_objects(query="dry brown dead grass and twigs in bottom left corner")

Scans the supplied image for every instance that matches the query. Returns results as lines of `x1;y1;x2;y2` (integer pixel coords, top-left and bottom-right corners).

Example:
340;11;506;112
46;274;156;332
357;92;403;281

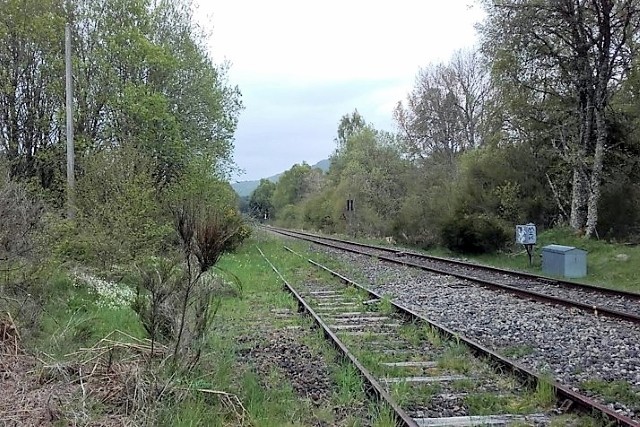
0;322;247;426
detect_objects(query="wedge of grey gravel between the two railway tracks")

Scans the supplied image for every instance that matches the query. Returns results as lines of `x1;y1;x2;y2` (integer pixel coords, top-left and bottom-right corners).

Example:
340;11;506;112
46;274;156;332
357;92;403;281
312;245;640;420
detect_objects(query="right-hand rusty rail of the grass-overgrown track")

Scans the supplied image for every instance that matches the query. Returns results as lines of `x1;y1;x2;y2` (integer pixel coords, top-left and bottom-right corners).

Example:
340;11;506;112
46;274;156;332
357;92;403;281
285;246;640;427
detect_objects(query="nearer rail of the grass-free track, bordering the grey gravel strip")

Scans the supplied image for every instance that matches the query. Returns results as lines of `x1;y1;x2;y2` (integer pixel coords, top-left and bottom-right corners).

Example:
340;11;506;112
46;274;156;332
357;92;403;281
266;229;640;324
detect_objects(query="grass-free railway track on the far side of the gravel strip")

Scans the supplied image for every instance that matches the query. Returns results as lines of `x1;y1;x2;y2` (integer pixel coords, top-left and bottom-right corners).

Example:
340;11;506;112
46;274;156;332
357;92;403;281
268;227;640;324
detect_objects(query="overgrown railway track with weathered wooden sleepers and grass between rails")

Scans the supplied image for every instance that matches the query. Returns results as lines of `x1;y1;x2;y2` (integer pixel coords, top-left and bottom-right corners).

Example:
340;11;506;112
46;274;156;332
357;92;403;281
260;244;640;427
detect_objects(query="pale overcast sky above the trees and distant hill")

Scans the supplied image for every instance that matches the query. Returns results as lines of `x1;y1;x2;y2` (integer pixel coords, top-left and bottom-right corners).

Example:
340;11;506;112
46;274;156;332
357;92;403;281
196;0;482;180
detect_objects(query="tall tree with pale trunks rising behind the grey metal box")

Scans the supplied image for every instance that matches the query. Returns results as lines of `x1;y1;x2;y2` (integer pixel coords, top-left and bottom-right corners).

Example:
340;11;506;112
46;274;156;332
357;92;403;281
481;0;640;237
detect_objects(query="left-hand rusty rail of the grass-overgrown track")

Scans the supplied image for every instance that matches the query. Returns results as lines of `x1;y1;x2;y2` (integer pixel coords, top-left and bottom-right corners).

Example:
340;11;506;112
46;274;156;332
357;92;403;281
256;246;419;427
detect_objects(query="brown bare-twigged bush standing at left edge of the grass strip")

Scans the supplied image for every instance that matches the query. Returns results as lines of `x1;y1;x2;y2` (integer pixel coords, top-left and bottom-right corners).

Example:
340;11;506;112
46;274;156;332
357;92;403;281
133;199;242;370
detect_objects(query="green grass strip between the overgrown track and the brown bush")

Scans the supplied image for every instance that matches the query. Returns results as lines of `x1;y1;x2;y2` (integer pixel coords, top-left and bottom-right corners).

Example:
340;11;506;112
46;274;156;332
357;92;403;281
161;233;394;427
